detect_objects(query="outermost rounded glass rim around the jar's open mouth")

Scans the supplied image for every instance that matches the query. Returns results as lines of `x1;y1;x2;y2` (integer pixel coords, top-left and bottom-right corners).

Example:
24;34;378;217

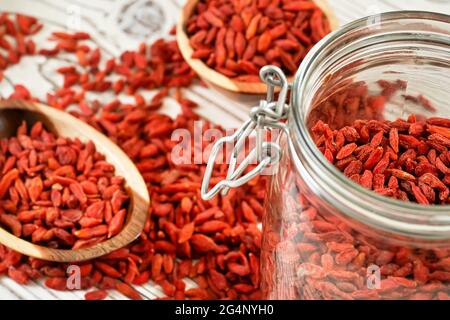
289;11;450;239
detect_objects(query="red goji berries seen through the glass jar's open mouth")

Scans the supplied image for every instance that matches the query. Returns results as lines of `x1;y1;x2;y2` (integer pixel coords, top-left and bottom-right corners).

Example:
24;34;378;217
309;81;450;205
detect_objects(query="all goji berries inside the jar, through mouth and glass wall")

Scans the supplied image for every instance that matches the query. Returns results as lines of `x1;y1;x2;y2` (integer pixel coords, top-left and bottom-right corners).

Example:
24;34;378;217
261;80;450;300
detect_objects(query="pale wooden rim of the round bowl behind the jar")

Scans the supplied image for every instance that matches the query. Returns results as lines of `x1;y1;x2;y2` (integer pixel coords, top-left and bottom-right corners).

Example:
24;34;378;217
177;0;339;94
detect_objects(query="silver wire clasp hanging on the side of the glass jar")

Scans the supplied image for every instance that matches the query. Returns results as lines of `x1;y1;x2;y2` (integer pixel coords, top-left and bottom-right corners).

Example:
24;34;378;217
201;66;291;200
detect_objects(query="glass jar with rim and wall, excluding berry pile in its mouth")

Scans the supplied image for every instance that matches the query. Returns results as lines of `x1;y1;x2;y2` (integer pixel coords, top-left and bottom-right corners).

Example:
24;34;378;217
261;12;450;299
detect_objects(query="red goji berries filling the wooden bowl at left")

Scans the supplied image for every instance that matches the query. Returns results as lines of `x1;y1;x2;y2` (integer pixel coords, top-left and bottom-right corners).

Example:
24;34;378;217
0;122;129;249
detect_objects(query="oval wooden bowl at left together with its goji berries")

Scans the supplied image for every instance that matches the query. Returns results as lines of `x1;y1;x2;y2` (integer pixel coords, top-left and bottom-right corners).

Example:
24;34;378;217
0;100;149;262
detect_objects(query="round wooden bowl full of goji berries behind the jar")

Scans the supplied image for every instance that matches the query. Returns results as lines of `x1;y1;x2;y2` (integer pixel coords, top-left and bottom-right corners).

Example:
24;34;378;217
177;0;338;94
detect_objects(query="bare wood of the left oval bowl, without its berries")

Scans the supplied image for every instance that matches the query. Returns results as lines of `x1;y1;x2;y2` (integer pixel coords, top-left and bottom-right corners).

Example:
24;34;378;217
0;100;150;262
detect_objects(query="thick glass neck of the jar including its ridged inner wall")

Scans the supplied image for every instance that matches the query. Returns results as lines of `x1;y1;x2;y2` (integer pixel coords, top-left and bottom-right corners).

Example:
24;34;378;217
289;11;450;240
